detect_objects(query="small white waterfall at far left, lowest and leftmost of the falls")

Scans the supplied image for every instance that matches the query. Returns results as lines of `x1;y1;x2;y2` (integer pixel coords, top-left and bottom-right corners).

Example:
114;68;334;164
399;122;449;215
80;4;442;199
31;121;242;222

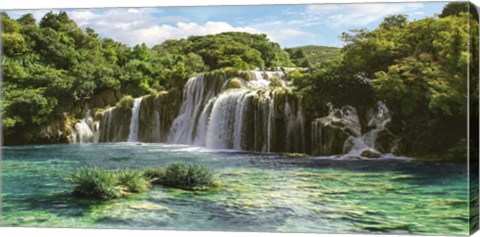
70;108;100;144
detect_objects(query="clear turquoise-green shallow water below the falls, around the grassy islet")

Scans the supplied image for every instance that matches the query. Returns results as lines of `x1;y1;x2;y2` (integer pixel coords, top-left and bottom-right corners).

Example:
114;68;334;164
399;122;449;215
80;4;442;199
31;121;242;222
0;143;468;235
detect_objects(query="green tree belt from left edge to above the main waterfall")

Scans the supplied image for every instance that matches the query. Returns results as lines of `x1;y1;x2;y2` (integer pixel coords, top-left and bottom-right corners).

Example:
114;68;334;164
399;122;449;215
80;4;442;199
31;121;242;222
0;12;292;145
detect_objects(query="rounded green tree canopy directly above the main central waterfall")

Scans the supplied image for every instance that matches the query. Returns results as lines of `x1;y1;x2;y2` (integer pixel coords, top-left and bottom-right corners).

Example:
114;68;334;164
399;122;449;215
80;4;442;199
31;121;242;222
153;32;292;70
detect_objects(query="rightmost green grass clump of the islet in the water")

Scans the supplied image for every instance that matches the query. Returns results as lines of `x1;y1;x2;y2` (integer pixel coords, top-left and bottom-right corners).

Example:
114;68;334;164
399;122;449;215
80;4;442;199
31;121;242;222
144;163;218;190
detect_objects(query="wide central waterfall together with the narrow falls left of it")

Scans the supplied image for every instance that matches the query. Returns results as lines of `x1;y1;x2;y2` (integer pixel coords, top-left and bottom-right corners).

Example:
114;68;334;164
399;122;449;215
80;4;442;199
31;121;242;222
91;70;305;152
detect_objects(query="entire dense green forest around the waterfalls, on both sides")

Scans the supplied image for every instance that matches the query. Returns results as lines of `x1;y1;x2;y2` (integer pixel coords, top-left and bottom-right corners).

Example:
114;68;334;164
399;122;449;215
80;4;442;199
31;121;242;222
1;1;478;159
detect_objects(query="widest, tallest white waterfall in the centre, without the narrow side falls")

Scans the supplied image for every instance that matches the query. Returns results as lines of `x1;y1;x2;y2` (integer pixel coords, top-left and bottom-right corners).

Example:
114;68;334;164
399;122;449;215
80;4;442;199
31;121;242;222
169;71;304;152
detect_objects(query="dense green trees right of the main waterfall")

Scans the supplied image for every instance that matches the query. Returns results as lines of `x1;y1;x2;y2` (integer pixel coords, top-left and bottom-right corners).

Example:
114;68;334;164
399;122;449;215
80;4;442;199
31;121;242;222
287;8;478;159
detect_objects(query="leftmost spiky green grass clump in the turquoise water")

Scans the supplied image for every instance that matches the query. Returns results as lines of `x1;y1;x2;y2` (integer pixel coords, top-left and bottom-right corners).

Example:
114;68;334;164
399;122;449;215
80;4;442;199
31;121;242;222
67;168;122;199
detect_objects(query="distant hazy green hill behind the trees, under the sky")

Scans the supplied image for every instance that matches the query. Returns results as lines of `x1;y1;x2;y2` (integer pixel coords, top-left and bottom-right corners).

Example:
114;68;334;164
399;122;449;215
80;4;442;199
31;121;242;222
285;45;341;67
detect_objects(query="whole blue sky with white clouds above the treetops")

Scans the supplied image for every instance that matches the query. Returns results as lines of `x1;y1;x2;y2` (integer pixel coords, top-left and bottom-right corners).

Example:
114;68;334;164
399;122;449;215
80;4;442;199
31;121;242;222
7;2;447;47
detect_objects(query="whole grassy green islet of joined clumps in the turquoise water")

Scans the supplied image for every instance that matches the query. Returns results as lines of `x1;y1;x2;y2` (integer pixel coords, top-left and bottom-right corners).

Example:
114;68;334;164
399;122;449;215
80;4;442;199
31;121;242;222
67;163;218;199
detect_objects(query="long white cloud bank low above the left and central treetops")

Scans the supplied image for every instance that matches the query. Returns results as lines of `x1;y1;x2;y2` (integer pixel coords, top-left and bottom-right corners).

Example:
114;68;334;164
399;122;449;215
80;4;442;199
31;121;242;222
64;8;308;46
